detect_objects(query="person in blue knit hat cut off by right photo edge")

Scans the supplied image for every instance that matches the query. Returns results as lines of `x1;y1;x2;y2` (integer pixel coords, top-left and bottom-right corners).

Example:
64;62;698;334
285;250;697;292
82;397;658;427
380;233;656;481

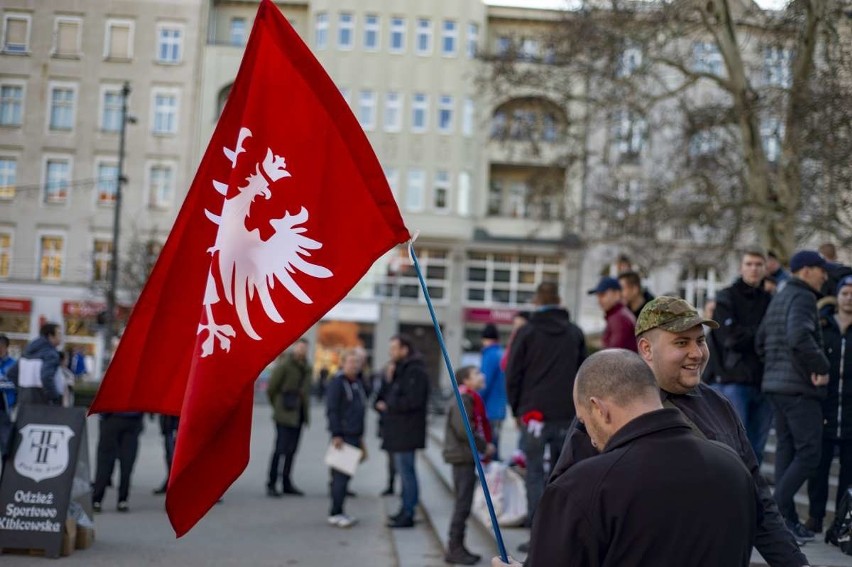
805;276;852;533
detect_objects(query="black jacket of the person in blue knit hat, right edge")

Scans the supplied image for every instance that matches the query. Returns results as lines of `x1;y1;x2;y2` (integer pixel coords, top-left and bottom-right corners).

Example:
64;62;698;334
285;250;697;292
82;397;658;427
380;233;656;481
822;315;852;439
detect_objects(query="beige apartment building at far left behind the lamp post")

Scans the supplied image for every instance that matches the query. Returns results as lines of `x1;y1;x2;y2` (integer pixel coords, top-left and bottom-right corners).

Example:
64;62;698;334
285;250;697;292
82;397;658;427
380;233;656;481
0;0;206;375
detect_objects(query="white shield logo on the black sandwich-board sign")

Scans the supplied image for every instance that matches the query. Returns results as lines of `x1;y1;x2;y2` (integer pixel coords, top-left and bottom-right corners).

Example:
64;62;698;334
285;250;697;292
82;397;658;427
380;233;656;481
15;423;74;482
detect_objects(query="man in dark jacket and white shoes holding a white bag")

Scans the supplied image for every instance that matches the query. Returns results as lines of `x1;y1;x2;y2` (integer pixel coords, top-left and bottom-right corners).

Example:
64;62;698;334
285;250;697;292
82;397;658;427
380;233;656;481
325;350;367;528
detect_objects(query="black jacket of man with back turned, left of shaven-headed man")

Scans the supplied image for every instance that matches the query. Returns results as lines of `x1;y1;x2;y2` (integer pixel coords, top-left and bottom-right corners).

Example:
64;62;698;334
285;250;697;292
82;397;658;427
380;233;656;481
506;308;586;421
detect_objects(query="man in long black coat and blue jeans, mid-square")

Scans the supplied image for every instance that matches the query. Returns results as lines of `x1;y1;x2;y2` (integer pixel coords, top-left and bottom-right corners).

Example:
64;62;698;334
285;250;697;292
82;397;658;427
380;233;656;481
375;335;429;528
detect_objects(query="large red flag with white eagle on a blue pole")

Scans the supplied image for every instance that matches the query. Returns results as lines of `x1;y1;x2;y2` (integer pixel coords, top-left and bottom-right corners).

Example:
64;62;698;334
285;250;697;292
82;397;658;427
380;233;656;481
90;0;409;537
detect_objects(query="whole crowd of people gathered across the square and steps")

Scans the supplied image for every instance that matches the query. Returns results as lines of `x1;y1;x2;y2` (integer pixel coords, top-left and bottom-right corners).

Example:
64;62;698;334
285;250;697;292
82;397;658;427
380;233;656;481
0;246;852;567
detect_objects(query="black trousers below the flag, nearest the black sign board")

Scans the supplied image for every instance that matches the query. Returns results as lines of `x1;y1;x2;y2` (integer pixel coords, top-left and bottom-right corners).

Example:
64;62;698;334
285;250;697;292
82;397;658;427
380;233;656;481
92;414;143;502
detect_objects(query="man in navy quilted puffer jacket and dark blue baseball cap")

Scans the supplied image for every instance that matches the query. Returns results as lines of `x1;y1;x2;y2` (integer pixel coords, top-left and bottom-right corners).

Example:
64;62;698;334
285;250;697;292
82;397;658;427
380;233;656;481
756;250;830;542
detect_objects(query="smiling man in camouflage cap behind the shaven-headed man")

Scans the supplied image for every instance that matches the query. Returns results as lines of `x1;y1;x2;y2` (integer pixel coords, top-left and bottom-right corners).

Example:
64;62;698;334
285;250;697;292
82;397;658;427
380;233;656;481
550;296;808;567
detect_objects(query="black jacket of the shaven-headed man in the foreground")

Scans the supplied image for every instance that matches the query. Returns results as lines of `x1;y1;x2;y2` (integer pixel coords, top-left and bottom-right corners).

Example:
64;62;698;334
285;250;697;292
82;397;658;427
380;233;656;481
527;409;759;567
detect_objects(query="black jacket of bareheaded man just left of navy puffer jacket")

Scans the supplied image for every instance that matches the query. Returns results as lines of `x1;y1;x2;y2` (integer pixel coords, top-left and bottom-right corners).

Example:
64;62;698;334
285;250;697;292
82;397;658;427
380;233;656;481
709;278;772;388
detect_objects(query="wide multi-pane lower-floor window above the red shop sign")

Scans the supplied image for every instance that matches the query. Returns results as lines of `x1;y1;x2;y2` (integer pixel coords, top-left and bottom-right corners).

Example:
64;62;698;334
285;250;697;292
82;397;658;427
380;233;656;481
464;251;563;307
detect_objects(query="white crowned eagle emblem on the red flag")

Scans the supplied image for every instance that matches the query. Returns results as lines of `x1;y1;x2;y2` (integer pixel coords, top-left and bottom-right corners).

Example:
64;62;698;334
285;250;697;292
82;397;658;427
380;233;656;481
198;128;333;357
